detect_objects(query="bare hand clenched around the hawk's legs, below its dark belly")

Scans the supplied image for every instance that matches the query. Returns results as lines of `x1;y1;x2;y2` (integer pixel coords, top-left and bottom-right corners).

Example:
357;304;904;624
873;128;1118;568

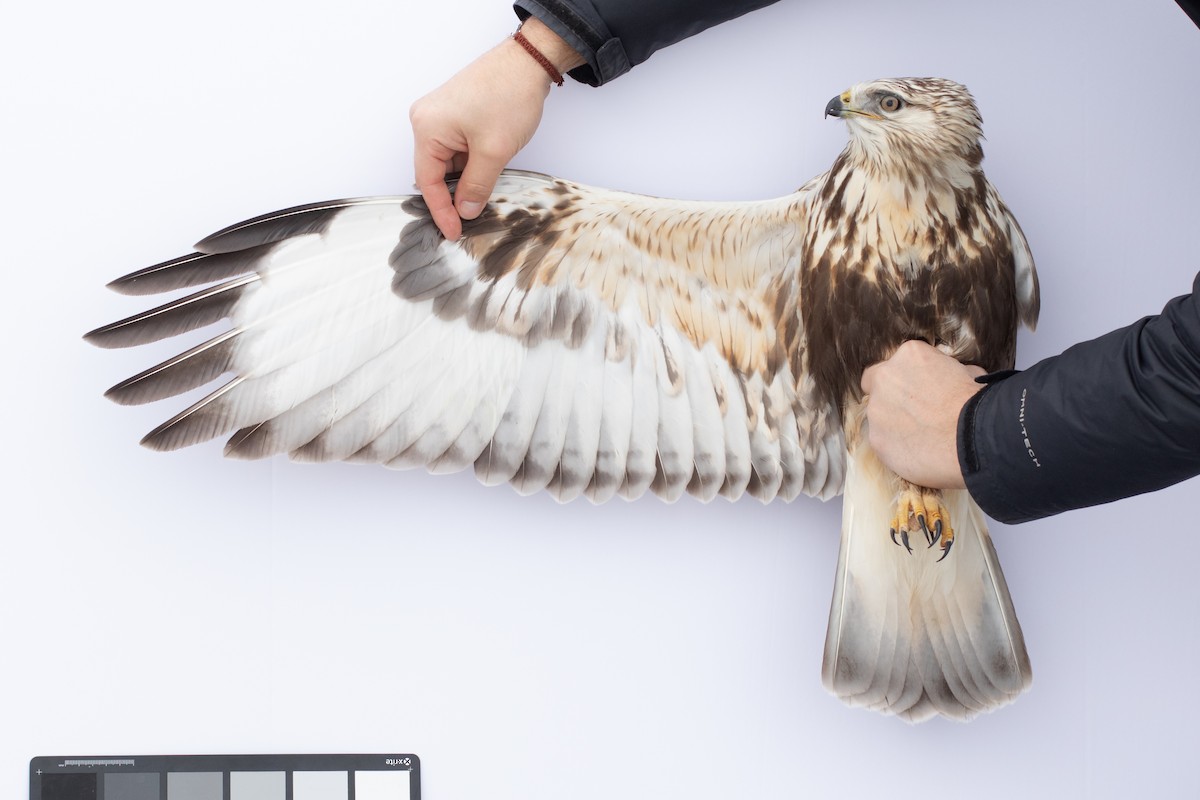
862;342;984;489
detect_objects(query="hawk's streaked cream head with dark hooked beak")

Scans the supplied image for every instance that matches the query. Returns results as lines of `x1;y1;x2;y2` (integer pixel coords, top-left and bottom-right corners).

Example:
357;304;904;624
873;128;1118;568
826;78;983;174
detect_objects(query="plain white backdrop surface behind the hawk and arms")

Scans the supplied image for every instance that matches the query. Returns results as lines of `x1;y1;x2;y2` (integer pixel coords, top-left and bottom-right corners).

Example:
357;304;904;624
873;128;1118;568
0;0;1200;800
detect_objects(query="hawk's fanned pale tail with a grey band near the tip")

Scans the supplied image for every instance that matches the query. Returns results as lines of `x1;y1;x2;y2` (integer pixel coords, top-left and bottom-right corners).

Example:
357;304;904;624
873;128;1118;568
822;429;1032;722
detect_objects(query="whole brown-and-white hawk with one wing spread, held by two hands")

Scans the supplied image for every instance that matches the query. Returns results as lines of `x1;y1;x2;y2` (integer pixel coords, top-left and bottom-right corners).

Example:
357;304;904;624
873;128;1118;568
88;79;1037;720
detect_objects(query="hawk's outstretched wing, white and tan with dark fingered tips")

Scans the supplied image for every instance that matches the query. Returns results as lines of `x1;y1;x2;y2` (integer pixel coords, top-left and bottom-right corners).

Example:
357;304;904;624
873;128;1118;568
88;172;842;501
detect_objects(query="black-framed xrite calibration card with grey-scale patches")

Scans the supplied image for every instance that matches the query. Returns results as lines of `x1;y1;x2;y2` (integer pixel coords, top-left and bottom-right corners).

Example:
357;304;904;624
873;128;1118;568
29;753;421;800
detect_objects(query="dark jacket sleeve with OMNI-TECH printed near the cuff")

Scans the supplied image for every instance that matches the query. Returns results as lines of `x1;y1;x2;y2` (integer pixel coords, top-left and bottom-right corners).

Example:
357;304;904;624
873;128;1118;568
959;275;1200;523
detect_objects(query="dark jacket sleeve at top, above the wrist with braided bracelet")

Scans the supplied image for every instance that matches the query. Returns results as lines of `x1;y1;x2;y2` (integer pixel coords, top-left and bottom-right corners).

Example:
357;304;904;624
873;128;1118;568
512;0;776;86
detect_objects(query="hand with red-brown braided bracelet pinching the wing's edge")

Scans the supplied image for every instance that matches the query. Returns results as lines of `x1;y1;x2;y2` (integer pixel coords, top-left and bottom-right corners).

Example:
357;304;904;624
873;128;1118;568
409;17;583;240
